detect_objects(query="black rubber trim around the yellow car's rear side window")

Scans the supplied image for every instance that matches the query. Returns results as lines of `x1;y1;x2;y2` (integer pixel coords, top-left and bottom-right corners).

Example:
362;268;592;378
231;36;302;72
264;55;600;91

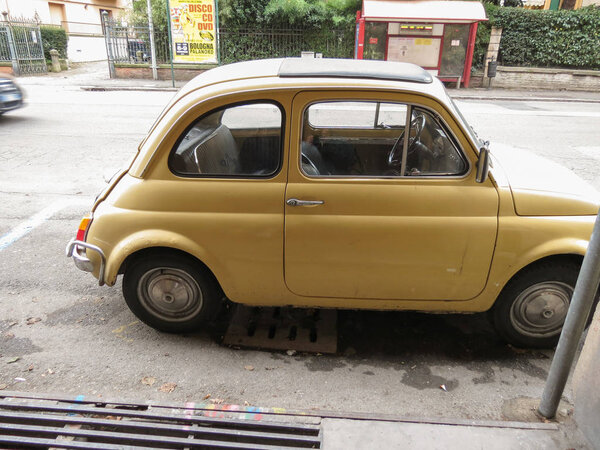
167;99;287;180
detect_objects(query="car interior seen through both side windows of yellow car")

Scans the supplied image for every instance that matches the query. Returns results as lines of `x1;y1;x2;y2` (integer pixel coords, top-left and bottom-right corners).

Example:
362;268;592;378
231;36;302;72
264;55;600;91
169;102;468;177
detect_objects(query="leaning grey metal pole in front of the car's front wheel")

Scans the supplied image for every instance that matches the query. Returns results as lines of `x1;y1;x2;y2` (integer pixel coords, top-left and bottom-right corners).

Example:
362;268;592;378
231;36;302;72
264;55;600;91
538;212;600;419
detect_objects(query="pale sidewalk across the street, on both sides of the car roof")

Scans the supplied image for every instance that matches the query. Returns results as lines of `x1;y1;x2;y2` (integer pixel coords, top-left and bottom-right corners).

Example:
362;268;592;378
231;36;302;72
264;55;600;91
12;61;600;103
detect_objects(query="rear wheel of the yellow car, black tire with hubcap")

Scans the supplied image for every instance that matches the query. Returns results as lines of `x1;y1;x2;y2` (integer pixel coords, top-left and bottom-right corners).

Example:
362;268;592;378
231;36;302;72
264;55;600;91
123;253;223;333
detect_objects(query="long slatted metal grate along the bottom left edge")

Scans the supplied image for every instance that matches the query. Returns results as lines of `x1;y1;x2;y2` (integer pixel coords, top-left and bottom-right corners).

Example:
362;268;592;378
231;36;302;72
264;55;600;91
0;397;321;450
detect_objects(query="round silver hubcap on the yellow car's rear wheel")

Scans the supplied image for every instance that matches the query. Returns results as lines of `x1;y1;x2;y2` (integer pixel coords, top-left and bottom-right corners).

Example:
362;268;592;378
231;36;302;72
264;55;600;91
137;267;203;322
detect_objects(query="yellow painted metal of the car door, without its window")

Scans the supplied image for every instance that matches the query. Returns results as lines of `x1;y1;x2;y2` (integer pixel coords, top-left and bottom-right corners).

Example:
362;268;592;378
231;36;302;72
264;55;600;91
285;90;498;300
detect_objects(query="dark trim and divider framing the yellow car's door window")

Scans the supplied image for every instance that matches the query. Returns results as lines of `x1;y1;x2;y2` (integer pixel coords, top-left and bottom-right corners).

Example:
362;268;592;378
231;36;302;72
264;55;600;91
298;98;473;181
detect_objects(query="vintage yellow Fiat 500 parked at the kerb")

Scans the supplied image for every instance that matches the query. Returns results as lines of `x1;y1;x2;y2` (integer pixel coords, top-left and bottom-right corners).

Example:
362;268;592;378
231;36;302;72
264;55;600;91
67;58;598;347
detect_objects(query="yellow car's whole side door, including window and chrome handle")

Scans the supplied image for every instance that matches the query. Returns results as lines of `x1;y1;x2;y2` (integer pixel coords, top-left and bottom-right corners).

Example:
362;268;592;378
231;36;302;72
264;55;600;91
284;91;498;300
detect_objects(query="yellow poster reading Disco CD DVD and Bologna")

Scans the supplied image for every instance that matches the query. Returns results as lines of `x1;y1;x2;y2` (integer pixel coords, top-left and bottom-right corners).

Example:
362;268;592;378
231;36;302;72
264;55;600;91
169;0;218;63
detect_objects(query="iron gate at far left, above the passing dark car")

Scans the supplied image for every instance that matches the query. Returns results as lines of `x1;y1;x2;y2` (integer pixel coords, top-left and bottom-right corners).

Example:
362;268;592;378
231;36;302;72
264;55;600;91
0;19;48;75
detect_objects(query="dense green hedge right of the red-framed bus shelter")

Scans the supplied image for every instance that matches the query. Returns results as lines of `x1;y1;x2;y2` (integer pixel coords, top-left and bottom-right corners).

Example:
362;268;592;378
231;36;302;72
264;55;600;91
473;5;600;69
